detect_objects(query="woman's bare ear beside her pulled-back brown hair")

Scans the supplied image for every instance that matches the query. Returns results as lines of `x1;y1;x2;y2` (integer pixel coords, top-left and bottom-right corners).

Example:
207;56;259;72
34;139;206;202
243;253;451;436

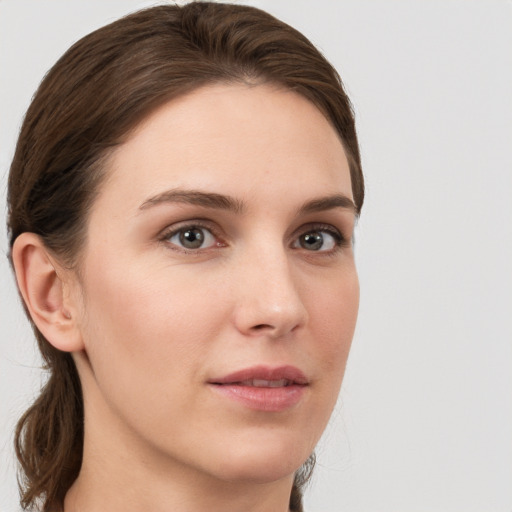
12;233;84;352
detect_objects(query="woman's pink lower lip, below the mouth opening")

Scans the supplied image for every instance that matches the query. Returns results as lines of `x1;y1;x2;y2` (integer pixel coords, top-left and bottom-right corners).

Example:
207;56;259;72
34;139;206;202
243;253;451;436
210;384;306;412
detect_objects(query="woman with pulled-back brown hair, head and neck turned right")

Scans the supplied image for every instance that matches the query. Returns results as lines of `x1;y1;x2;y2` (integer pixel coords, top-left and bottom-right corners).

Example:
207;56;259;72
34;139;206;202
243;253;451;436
8;2;364;512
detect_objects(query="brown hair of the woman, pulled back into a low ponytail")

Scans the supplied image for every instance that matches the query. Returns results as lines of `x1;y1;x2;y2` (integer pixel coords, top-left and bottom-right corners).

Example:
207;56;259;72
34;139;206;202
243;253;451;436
8;2;364;512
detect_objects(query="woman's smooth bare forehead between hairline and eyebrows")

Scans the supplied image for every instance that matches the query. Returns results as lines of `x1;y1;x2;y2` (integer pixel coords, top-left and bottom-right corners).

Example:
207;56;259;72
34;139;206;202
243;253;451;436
92;84;352;218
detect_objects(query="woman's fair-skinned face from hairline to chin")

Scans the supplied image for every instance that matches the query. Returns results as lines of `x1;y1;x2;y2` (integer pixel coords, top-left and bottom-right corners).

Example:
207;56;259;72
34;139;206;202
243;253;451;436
72;85;359;488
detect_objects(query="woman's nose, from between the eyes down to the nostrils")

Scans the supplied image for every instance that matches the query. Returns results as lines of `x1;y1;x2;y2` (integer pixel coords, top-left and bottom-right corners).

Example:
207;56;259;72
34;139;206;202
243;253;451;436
234;248;308;339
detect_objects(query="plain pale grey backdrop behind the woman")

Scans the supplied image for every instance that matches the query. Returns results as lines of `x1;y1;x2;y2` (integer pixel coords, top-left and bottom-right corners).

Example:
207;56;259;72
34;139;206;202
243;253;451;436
0;0;512;512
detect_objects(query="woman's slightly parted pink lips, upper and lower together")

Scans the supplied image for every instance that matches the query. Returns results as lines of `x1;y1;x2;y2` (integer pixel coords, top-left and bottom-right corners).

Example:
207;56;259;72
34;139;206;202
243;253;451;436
208;366;309;412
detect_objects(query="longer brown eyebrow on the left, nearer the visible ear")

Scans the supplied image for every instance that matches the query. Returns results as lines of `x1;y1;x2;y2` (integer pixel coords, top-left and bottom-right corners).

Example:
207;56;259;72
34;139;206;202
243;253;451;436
139;189;245;213
